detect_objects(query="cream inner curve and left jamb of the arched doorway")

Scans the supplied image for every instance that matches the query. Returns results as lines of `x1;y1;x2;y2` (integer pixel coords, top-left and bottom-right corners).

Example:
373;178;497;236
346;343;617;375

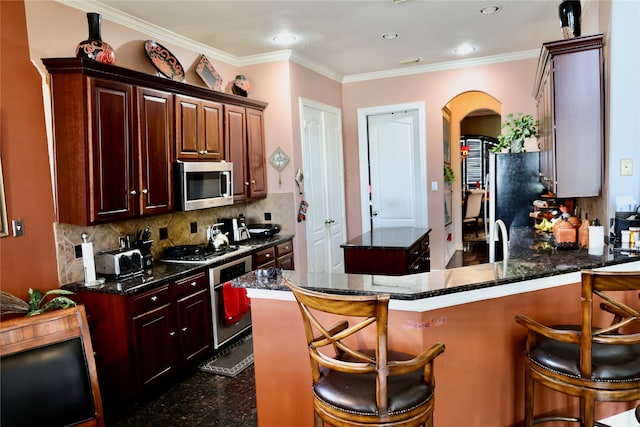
442;91;502;264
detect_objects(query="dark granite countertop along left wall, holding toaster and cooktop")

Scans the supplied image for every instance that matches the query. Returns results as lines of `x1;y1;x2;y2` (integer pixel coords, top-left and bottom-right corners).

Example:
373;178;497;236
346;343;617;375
62;234;293;295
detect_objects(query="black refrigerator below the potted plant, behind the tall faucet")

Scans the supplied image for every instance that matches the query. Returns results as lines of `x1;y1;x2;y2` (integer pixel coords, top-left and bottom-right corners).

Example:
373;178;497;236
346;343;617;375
485;152;543;262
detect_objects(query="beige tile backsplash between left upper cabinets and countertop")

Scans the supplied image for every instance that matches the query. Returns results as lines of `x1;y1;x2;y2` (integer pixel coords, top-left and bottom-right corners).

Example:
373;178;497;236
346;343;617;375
55;193;296;284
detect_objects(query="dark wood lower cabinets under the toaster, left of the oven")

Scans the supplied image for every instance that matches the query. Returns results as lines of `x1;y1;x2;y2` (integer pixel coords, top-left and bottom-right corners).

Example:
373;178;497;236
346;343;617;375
74;270;213;404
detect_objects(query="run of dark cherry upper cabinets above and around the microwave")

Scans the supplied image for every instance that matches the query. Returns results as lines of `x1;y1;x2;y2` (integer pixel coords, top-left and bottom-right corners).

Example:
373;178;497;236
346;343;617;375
42;58;267;225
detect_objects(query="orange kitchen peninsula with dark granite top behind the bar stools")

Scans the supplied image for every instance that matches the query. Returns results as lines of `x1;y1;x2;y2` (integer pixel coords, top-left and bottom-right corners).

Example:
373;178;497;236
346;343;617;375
234;230;640;427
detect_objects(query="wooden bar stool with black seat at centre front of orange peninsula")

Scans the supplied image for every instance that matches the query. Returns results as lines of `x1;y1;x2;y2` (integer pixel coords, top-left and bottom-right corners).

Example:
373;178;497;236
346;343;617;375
285;280;444;427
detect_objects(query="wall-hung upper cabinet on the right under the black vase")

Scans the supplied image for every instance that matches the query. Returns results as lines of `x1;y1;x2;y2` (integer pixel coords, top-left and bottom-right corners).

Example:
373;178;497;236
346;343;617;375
533;34;604;197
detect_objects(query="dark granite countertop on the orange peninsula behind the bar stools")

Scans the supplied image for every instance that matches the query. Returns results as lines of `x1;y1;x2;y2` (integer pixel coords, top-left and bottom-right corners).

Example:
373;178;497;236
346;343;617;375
232;227;640;300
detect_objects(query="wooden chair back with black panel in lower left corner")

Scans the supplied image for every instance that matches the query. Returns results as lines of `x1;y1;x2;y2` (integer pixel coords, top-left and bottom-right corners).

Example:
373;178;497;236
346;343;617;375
0;306;104;426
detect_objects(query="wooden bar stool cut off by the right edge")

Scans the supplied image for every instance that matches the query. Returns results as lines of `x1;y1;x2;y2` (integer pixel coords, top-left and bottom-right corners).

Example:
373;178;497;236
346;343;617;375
516;270;640;427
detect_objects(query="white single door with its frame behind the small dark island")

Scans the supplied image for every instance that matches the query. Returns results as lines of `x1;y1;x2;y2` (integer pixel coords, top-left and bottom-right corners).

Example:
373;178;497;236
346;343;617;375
359;104;428;232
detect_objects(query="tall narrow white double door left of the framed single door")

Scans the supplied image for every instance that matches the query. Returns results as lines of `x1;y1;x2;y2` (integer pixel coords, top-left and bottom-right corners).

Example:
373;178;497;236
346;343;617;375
300;99;346;273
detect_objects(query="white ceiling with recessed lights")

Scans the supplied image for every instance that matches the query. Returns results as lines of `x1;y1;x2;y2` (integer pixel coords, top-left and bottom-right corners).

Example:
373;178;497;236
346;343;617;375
84;0;568;78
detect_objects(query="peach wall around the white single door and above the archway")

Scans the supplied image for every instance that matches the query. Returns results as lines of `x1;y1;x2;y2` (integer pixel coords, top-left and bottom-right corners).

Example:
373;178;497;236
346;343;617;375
342;58;537;269
